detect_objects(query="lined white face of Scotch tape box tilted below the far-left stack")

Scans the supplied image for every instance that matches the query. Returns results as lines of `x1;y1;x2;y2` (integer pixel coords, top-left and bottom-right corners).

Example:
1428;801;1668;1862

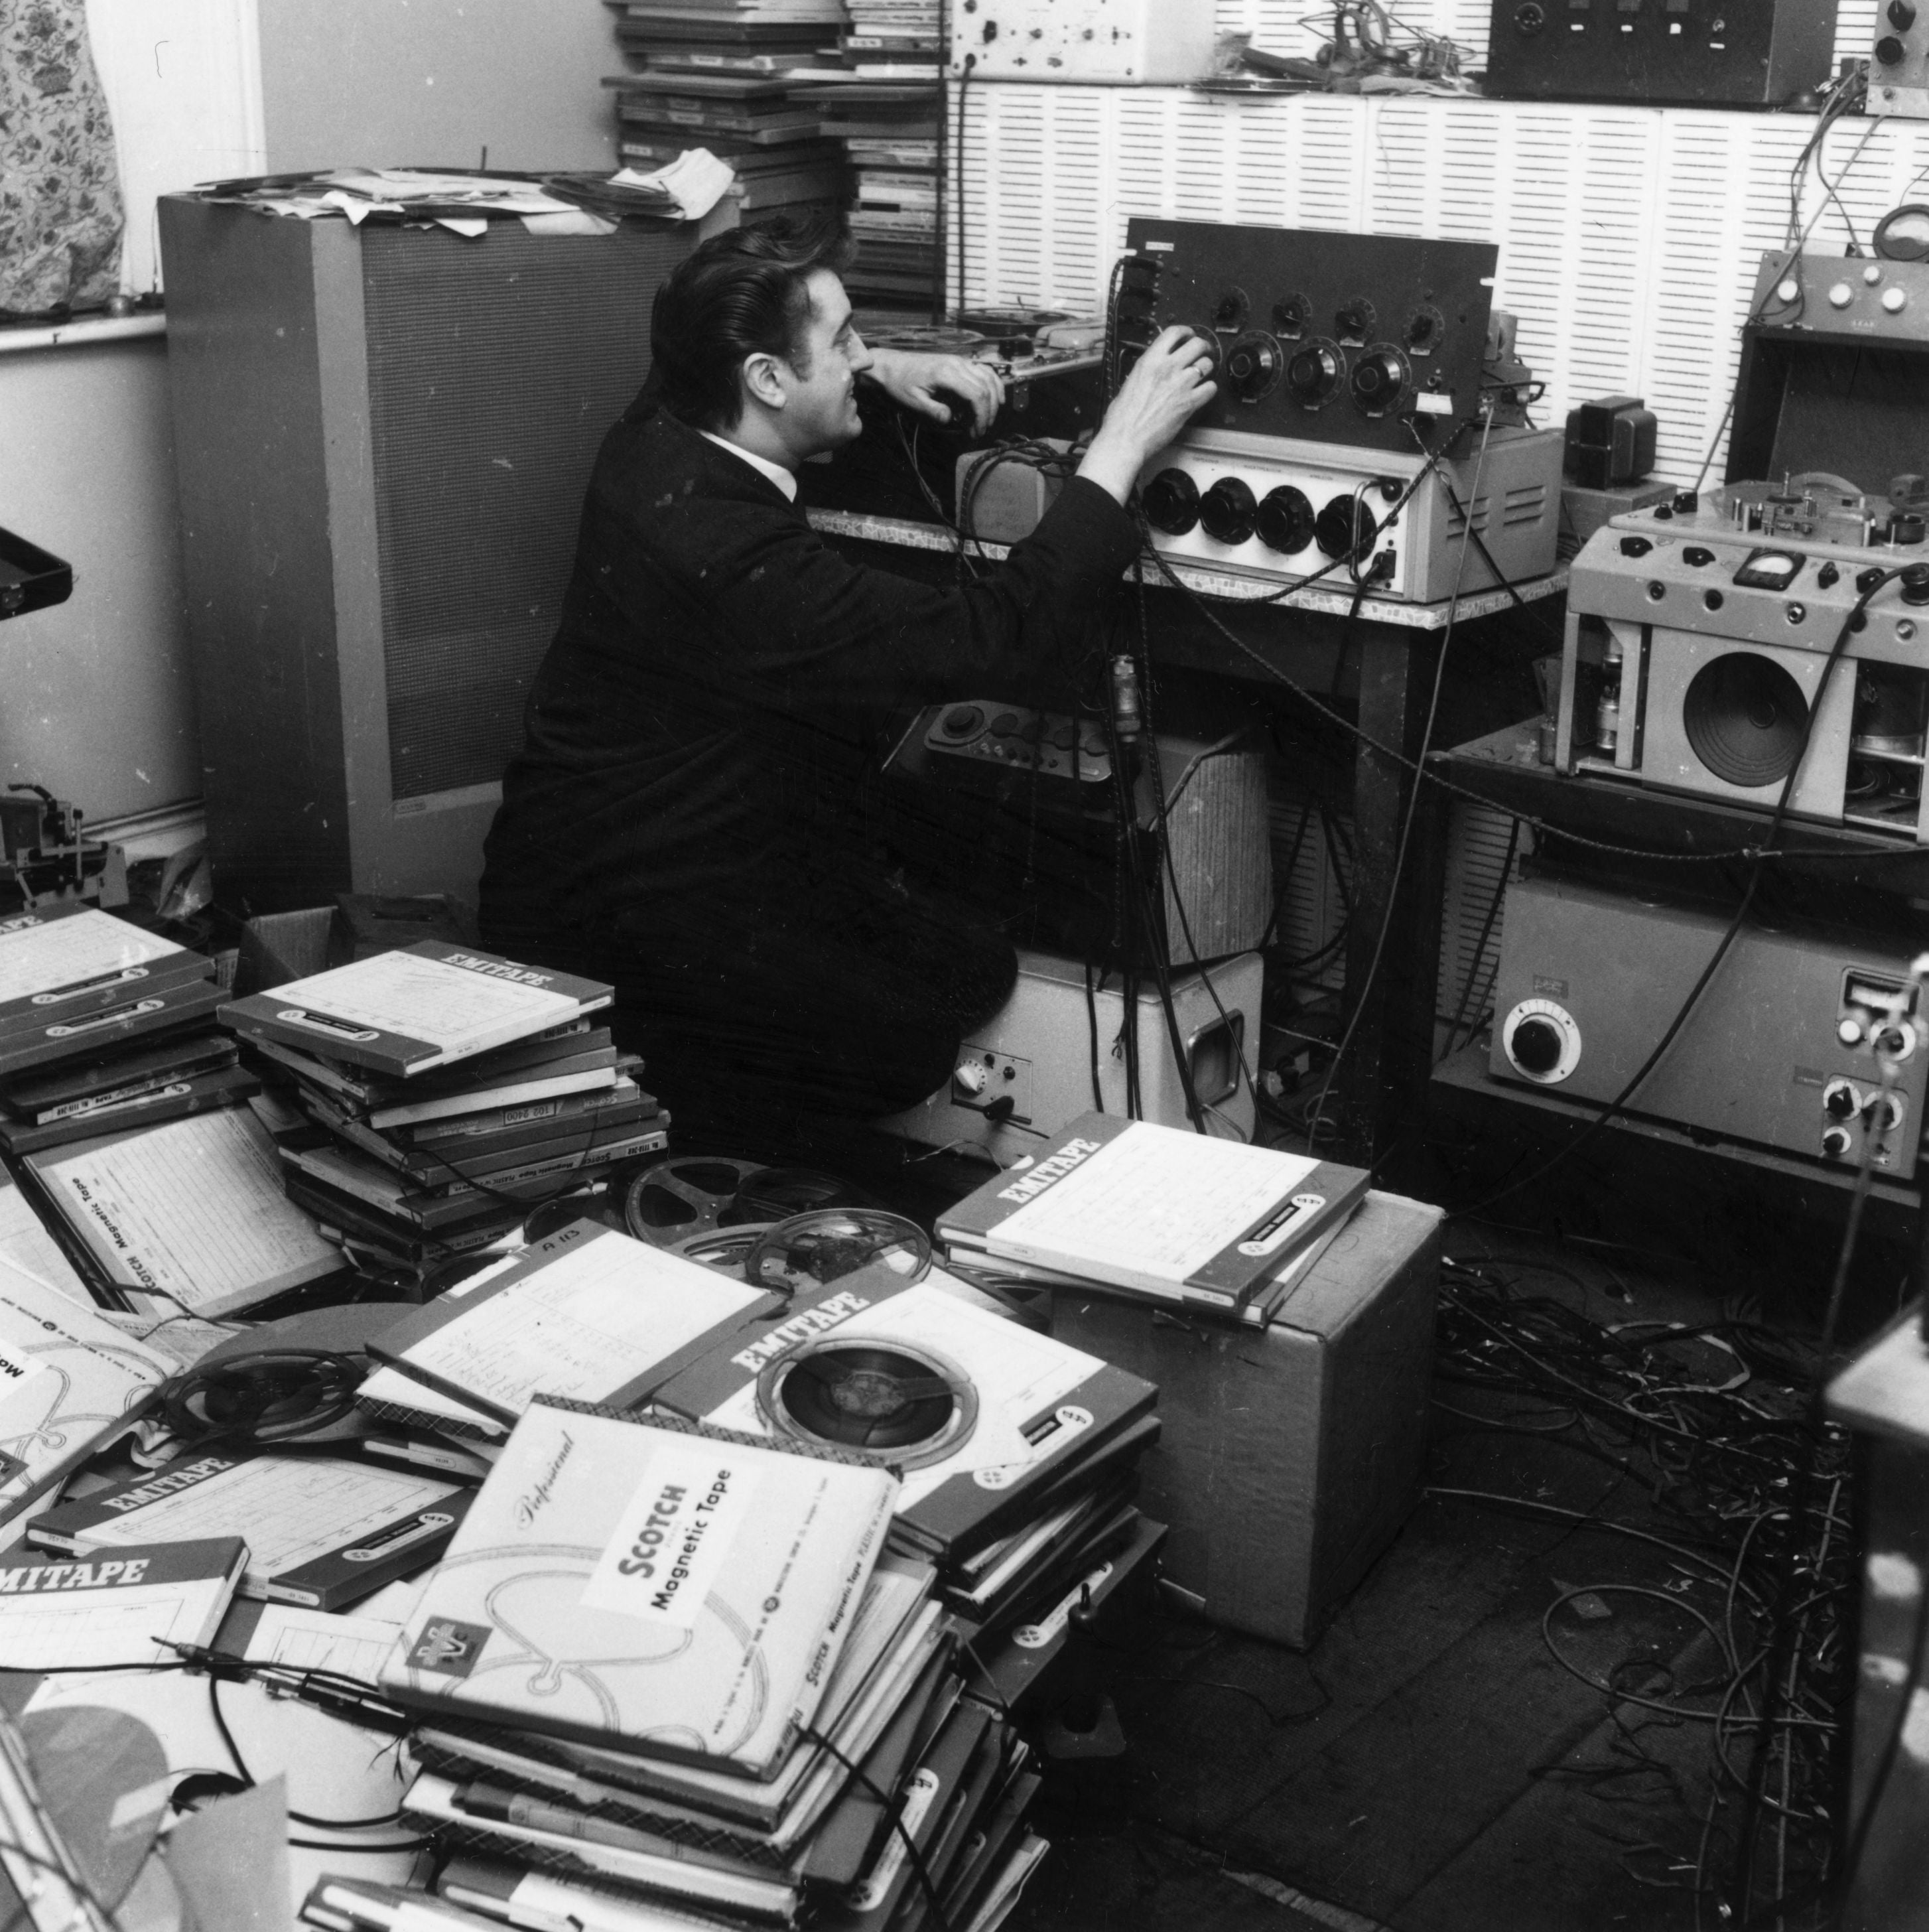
29;1107;342;1312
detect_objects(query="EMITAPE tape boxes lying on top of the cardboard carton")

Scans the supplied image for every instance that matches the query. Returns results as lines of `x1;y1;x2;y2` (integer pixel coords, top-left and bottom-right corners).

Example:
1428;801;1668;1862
937;1113;1371;1328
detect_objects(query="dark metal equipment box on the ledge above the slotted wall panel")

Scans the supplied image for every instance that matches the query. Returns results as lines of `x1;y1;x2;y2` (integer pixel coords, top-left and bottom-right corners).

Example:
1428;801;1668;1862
1485;0;1838;114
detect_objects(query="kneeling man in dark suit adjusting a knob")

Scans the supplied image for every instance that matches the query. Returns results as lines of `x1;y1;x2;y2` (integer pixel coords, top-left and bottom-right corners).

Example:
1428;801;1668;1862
481;224;1213;1144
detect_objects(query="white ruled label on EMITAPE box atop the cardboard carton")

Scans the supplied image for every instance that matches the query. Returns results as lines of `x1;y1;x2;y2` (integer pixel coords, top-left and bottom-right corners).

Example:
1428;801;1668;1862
985;1131;1317;1286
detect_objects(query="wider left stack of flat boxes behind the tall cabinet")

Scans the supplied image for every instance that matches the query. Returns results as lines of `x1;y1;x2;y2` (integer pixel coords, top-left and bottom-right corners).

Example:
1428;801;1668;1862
606;0;846;222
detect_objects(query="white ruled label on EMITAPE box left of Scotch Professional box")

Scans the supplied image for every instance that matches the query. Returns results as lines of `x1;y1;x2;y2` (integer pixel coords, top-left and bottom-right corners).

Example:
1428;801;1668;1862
70;1457;462;1576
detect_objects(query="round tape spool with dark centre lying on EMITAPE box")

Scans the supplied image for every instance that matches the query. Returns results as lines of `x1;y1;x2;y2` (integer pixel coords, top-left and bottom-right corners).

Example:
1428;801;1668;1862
757;1337;977;1468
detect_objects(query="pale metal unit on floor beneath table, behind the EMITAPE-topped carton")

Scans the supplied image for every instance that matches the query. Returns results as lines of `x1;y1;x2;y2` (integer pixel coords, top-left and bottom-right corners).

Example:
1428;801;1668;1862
875;951;1265;1163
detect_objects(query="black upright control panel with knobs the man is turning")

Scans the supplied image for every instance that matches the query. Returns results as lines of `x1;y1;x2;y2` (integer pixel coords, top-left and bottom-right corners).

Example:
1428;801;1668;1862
1112;216;1498;454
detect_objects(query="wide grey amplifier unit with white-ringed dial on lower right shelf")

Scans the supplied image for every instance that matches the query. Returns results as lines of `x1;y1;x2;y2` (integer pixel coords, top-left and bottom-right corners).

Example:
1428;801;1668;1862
1489;877;1929;1178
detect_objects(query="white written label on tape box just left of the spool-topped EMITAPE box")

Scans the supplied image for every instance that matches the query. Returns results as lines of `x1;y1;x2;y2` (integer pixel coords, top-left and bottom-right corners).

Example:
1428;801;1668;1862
401;1241;757;1414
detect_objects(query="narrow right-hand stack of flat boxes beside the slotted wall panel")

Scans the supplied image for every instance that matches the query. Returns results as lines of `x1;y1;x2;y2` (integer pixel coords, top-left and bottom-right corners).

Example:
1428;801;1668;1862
825;0;943;305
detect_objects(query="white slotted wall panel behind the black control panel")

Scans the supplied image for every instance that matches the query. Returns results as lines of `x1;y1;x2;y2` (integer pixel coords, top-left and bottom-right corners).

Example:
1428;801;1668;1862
950;88;1929;483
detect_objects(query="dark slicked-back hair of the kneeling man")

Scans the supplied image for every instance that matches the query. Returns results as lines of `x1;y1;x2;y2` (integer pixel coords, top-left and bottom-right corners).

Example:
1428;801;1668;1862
649;218;850;429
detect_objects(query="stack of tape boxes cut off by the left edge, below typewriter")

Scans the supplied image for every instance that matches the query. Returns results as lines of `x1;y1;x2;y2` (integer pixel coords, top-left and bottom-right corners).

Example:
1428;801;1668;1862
0;906;257;1153
